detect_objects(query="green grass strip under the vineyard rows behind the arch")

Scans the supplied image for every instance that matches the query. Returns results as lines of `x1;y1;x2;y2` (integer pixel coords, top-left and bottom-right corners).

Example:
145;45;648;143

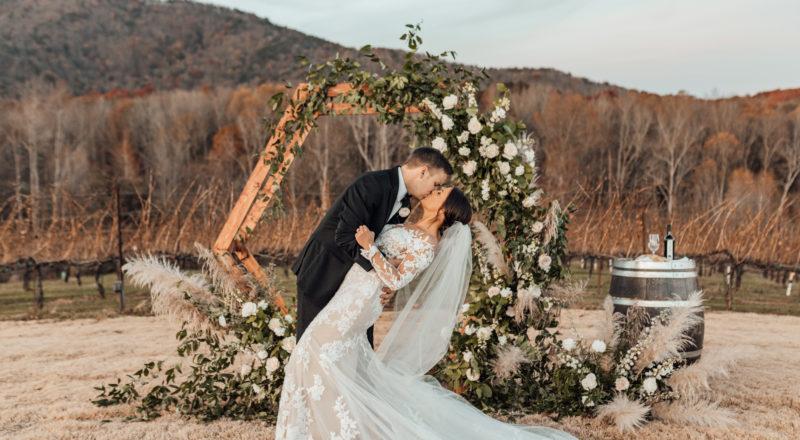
0;264;800;320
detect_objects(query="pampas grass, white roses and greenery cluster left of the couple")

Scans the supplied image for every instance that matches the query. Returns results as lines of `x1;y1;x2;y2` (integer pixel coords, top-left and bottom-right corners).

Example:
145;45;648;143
92;245;296;421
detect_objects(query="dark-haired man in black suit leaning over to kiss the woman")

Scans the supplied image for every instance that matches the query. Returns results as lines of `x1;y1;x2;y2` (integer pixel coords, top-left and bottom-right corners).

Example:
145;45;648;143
292;147;453;349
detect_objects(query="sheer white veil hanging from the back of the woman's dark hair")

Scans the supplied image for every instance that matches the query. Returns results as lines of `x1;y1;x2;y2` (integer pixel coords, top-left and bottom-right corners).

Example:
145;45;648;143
377;222;472;376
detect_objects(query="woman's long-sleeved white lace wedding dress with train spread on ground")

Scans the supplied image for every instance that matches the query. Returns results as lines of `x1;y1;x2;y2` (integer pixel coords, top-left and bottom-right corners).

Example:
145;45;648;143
275;225;574;440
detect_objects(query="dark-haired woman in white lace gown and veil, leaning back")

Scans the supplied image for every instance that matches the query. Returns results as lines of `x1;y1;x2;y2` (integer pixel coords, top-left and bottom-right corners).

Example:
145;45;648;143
275;187;574;440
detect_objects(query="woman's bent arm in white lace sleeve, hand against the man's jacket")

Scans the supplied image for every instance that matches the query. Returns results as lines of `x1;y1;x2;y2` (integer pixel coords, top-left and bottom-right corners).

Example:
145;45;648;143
356;226;433;290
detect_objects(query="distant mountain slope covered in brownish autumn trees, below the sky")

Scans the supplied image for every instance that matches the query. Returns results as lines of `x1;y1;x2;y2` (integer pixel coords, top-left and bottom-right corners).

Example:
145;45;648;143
0;0;619;96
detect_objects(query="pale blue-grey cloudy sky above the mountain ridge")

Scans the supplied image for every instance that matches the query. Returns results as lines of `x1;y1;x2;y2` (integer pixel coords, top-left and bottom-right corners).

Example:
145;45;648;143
198;0;800;98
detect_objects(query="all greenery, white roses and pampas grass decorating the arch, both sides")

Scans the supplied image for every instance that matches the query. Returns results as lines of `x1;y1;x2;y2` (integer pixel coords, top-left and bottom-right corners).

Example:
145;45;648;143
95;25;733;430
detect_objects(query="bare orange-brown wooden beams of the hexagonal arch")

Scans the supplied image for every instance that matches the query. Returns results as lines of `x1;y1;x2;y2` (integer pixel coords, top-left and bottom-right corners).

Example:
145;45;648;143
212;83;419;313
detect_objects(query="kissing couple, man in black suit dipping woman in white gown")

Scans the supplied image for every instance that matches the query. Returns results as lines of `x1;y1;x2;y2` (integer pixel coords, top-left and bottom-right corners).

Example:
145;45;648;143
275;147;575;440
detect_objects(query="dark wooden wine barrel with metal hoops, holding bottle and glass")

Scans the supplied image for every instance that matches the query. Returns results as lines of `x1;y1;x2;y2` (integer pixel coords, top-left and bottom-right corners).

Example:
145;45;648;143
609;258;705;364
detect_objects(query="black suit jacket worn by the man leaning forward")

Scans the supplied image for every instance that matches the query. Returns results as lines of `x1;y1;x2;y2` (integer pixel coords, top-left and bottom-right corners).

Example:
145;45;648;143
292;167;409;347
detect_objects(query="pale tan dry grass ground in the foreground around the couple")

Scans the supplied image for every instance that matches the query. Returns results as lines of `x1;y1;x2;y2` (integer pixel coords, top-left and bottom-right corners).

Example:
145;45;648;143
0;310;800;440
